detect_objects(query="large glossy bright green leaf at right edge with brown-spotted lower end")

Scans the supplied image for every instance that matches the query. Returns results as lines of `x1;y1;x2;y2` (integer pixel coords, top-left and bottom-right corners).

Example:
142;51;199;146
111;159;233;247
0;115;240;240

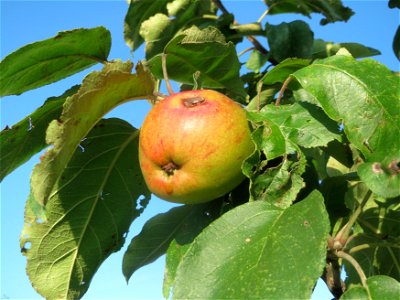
293;54;400;197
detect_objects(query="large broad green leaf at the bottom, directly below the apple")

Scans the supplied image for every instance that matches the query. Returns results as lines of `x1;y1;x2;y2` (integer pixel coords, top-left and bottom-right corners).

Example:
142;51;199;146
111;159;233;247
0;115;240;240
173;192;329;299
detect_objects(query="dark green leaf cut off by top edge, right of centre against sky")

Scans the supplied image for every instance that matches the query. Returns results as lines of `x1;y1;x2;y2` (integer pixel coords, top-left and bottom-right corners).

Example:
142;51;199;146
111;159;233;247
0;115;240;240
264;0;354;25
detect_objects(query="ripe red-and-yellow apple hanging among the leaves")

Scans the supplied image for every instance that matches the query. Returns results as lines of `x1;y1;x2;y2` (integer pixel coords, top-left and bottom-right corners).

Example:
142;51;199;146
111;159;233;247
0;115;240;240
139;90;254;204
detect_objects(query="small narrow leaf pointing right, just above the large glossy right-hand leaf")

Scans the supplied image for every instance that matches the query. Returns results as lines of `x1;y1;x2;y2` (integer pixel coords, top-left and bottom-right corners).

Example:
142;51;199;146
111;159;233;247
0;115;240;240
312;39;381;58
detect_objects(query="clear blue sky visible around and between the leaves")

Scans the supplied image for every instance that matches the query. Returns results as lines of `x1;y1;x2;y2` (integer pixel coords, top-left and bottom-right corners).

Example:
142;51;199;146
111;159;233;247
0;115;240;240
0;0;399;299
